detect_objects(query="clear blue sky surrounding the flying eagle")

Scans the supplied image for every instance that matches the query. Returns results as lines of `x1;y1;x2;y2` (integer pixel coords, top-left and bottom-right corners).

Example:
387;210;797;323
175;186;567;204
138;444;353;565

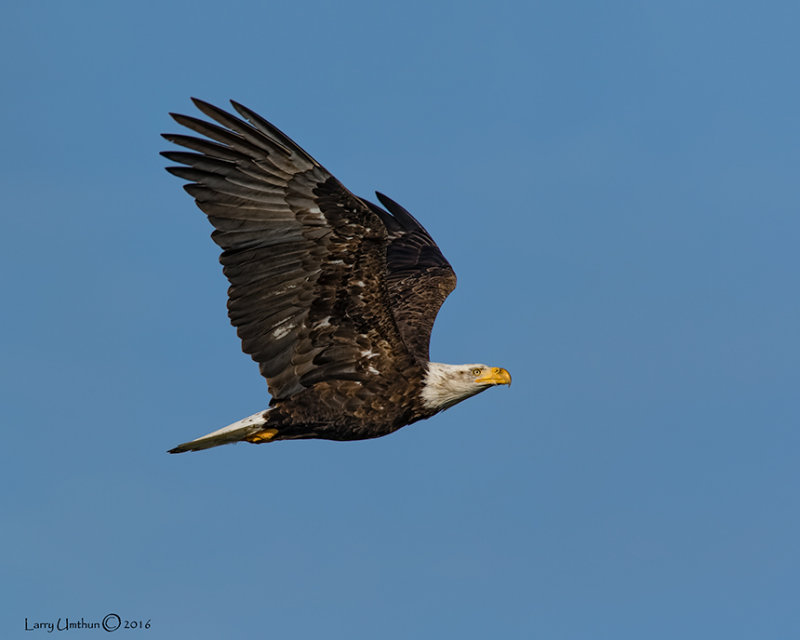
0;1;800;640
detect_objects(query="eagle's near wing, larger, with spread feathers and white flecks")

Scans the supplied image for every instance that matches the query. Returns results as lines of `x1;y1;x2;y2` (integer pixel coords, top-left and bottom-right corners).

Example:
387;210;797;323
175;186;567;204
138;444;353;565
163;99;411;400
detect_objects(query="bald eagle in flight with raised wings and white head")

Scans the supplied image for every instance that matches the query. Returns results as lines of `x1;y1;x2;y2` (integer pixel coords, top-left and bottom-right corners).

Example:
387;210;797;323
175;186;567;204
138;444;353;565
162;99;511;453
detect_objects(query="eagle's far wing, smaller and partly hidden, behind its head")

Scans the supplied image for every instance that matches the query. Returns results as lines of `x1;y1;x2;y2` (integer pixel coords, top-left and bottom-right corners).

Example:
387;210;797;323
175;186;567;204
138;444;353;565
365;192;456;362
